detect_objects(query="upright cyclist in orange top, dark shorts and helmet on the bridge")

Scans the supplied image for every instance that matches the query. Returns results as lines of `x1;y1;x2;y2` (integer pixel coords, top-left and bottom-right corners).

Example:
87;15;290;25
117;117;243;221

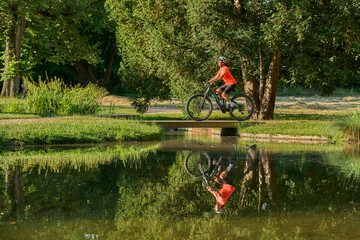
208;57;236;112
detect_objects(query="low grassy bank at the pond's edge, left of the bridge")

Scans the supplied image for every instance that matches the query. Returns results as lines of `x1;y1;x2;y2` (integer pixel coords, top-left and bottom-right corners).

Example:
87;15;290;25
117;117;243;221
0;117;161;146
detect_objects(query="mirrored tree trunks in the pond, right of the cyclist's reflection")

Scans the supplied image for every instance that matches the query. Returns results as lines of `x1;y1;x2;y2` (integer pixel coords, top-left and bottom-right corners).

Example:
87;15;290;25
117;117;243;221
240;150;278;211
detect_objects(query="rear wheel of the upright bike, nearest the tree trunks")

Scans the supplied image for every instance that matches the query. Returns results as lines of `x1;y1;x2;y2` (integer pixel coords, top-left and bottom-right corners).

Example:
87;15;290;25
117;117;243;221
230;94;254;121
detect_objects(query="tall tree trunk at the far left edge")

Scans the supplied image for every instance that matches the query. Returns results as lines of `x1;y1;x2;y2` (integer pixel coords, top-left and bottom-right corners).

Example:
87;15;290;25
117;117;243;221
1;15;26;97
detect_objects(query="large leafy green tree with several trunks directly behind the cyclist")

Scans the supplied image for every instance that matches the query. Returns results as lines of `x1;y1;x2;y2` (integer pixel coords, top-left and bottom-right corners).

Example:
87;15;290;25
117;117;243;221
107;0;359;119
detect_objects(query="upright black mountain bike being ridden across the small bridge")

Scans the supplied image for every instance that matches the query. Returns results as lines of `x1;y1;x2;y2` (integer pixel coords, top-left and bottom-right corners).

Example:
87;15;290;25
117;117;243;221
186;81;254;121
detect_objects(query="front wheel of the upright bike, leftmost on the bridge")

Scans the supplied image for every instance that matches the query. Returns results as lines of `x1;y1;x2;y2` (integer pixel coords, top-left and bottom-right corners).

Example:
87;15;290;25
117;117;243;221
186;93;213;121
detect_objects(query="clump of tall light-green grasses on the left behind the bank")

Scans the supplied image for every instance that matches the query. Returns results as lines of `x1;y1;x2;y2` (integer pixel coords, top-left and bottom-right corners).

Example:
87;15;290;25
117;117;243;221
25;78;107;114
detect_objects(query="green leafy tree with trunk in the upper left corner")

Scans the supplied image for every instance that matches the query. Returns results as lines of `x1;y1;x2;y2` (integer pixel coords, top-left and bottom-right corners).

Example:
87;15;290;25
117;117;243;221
0;0;117;96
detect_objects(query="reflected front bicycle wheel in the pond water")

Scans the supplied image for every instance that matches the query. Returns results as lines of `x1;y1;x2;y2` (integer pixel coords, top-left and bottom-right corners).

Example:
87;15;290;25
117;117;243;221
185;152;211;177
